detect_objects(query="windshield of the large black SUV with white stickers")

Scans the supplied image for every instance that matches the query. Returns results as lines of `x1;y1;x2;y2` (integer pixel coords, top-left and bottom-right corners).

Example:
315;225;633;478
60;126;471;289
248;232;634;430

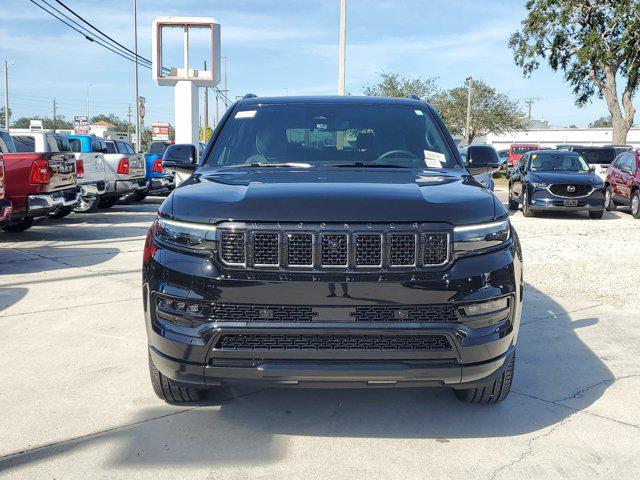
205;102;457;168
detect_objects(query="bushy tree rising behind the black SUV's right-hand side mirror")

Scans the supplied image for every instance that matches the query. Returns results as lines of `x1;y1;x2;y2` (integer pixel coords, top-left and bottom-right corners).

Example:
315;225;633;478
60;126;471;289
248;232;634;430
432;80;527;142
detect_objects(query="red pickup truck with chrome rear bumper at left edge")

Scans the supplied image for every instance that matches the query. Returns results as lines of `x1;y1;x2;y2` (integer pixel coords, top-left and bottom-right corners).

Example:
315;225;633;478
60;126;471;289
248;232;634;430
0;129;80;232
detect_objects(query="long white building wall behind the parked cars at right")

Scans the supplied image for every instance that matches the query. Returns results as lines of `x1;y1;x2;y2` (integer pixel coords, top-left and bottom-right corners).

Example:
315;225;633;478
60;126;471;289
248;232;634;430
487;128;640;150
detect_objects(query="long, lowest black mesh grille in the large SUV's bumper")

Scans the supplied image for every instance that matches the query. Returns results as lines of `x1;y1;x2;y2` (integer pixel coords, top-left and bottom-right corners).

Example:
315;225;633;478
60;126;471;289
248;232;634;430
216;334;451;351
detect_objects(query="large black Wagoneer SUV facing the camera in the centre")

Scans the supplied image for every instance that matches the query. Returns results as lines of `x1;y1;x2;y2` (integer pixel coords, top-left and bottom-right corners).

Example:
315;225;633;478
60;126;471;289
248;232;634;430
143;97;523;403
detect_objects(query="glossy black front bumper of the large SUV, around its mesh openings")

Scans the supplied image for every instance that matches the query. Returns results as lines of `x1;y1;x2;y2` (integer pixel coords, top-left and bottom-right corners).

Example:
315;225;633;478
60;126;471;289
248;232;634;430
143;238;522;388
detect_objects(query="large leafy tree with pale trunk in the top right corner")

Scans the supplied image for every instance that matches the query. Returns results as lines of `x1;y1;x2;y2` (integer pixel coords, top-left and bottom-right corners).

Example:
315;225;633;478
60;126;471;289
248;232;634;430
509;0;640;145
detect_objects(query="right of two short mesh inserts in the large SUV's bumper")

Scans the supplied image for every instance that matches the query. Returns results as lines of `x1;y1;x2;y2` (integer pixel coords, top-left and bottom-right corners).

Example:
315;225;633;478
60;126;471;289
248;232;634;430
349;305;459;322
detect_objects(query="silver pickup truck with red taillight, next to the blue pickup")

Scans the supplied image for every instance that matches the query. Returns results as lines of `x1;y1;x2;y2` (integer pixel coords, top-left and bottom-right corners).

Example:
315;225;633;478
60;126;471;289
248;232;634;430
92;139;149;208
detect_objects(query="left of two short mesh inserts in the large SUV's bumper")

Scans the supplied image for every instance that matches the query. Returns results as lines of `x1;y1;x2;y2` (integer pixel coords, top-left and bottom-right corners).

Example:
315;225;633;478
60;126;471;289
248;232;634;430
211;303;318;322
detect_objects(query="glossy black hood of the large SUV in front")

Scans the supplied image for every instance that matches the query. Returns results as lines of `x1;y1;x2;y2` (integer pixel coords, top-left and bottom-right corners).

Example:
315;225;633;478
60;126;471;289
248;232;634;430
161;168;504;224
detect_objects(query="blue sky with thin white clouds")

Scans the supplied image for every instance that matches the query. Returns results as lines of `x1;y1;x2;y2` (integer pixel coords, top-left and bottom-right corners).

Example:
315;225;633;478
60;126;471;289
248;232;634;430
0;0;620;126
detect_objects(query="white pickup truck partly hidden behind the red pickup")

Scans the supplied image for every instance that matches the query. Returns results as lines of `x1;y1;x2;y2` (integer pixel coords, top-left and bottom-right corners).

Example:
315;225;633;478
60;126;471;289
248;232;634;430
10;129;106;213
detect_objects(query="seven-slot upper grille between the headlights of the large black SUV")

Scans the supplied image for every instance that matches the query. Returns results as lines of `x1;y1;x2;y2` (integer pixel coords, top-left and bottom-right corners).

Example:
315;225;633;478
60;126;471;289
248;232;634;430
218;224;450;271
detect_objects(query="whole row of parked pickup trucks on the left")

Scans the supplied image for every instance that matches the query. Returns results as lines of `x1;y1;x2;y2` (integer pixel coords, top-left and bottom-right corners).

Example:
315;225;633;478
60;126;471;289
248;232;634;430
0;129;173;232
